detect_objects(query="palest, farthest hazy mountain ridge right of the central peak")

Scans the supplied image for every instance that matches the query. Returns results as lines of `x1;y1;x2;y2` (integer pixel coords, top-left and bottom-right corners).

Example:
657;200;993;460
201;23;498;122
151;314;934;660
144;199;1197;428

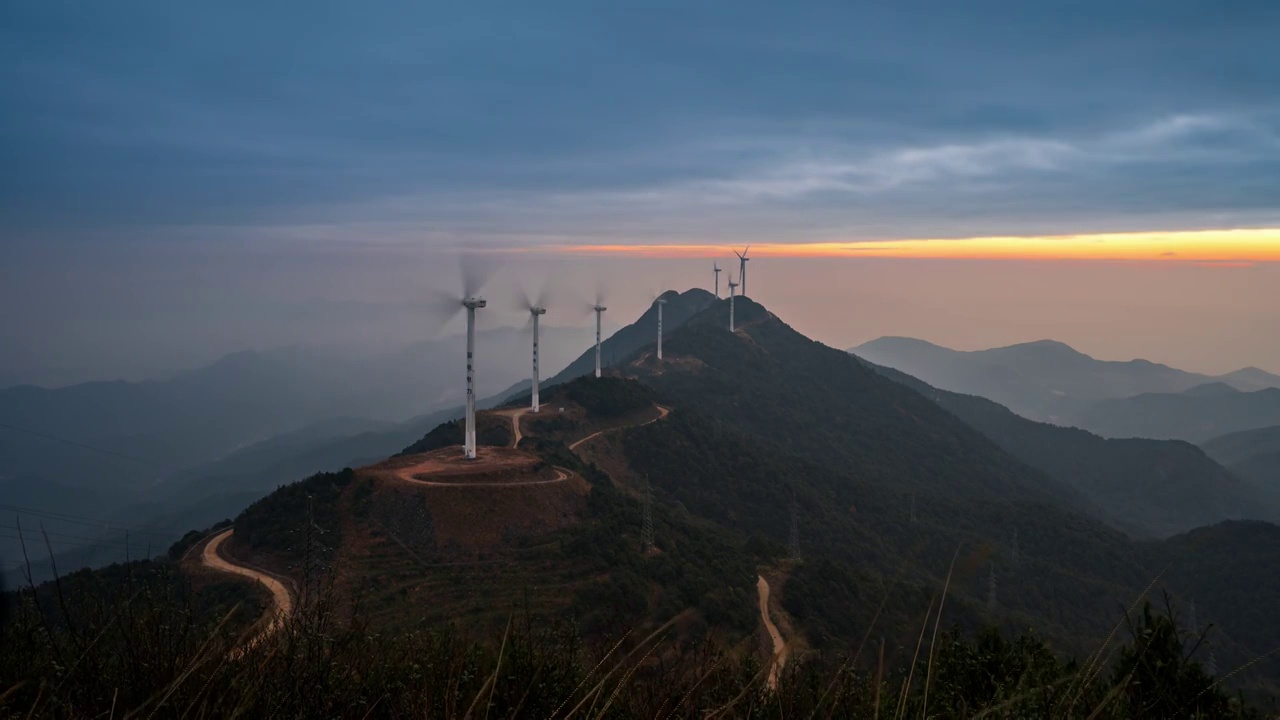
850;337;1280;429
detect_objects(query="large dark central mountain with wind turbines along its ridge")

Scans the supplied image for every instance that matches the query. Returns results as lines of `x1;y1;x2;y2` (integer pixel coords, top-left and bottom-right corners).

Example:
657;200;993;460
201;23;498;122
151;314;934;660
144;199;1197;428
17;293;1280;683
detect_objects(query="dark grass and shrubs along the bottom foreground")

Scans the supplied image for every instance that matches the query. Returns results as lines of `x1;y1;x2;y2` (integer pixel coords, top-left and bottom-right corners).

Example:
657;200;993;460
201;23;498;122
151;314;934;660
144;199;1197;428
0;562;1258;717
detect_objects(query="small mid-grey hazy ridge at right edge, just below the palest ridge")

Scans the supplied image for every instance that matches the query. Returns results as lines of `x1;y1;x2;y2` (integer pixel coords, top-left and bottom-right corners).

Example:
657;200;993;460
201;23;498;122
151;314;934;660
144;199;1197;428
1074;383;1280;442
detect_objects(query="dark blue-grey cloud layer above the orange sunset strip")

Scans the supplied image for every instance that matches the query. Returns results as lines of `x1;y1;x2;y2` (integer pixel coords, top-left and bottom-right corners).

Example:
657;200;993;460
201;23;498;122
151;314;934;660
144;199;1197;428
0;0;1280;240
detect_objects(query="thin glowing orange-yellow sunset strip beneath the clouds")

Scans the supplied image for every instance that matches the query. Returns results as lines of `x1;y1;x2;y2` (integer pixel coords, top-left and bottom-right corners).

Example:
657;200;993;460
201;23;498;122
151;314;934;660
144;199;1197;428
548;228;1280;264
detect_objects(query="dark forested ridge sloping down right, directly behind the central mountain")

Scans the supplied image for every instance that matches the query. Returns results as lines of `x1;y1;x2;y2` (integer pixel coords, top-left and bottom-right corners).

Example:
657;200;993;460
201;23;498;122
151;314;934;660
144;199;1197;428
873;365;1280;537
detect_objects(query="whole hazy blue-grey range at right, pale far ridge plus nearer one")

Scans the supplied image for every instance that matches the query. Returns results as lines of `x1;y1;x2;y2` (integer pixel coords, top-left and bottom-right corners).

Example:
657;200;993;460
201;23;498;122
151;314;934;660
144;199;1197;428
850;337;1280;441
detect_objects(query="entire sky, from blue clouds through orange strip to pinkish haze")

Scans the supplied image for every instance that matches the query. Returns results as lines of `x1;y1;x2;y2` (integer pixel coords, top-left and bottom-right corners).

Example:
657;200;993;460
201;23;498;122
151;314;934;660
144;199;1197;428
0;0;1280;384
